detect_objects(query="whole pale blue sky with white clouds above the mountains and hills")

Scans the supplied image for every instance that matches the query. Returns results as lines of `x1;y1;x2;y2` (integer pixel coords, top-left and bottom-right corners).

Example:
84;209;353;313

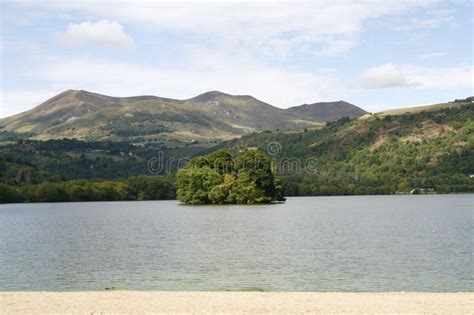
0;0;474;117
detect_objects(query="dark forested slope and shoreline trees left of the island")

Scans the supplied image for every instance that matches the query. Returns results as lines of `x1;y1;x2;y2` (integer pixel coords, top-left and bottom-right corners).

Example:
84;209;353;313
0;139;183;203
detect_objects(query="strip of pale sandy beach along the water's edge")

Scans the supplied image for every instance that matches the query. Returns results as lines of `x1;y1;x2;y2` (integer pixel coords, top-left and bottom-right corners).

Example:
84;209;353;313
0;291;474;314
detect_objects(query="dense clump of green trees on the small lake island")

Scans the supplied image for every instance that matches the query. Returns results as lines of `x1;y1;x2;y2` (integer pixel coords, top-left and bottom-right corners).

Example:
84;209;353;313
177;150;285;204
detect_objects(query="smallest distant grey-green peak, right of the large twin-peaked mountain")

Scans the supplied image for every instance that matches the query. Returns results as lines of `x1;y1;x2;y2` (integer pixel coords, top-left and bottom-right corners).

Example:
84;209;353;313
287;101;367;122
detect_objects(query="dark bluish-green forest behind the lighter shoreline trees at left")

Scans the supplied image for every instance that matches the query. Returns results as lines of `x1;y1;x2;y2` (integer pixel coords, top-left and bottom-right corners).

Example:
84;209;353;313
0;139;207;185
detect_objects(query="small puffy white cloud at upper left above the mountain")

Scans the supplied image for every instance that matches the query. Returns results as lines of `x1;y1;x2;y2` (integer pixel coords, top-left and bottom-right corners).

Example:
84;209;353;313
61;20;134;48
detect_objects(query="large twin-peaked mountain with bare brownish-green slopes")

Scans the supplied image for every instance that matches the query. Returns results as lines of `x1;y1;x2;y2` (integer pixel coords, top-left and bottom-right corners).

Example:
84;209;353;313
0;90;322;141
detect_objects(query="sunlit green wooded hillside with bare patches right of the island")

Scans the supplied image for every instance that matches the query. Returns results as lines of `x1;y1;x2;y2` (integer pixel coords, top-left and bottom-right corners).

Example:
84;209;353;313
223;104;474;196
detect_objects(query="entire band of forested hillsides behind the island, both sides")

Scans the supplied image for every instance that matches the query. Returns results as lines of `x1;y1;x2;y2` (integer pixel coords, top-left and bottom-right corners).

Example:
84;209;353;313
0;101;474;202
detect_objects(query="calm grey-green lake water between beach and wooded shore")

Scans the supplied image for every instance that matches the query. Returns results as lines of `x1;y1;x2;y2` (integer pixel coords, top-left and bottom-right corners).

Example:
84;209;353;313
0;195;474;292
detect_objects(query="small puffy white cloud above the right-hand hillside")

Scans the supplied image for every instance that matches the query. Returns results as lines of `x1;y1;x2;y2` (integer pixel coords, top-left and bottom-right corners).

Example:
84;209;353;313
359;63;414;89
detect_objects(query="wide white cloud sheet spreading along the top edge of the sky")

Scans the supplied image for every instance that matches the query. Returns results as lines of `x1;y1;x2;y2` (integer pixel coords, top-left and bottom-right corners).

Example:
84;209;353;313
22;0;433;57
